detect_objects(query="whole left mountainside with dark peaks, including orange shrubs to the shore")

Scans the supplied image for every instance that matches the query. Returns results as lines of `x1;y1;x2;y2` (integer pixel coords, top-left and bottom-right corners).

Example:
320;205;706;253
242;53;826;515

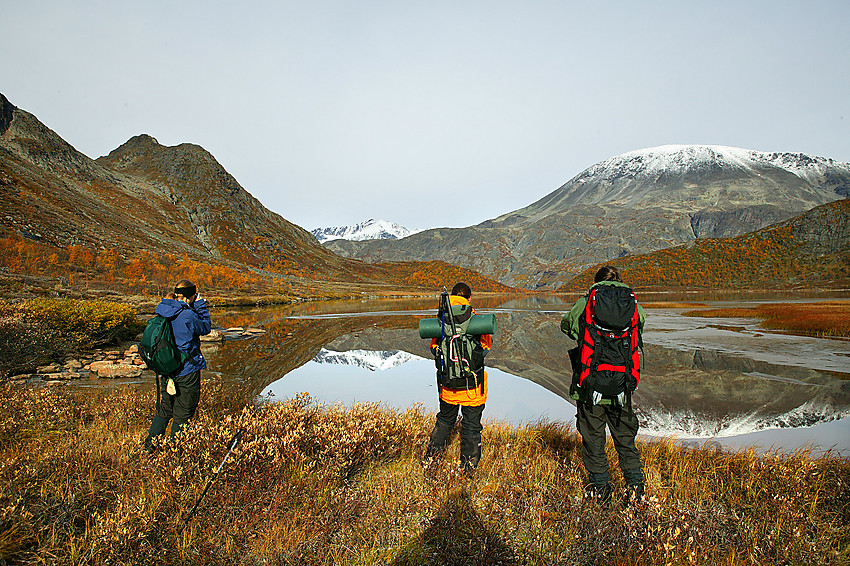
0;94;505;292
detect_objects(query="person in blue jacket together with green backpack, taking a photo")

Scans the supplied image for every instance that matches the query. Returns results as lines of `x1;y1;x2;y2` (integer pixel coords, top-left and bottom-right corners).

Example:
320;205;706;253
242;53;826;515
140;279;212;452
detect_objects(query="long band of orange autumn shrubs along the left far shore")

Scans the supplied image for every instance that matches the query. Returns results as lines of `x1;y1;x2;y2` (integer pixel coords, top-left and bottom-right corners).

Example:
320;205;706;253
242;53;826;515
0;235;514;296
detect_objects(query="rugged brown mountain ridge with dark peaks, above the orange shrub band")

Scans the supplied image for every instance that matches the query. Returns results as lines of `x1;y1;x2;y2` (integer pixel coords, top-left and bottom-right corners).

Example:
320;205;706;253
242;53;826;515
0;93;342;266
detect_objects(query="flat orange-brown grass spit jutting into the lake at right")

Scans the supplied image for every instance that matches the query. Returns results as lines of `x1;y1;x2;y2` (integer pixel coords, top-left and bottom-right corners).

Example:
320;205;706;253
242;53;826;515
684;301;850;337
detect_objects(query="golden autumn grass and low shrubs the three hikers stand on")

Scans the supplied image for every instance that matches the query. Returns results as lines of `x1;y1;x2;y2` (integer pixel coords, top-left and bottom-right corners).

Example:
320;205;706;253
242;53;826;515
0;381;850;565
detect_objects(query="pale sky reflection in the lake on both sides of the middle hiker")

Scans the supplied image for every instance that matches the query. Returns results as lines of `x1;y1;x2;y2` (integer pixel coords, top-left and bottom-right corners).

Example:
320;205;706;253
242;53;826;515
263;357;575;424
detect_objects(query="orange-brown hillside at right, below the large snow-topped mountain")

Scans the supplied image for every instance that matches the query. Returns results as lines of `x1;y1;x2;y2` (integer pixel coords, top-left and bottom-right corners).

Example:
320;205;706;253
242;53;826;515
560;199;850;291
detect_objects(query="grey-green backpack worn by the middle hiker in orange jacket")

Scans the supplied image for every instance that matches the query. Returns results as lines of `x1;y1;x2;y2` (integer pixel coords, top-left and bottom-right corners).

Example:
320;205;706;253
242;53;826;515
435;297;484;390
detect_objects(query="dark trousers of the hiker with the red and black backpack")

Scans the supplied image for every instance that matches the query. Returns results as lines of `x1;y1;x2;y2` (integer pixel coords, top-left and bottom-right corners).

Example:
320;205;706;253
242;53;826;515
576;402;643;485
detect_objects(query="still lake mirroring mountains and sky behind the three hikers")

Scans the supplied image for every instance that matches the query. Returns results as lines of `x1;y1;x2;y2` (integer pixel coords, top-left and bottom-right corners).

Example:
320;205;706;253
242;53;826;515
204;294;850;455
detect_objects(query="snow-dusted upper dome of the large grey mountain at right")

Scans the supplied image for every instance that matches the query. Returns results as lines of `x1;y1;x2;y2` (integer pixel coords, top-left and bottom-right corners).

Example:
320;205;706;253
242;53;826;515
536;145;850;213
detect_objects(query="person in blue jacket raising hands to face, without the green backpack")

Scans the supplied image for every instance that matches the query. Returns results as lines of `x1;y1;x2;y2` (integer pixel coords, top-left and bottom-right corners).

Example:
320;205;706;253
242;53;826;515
145;279;211;452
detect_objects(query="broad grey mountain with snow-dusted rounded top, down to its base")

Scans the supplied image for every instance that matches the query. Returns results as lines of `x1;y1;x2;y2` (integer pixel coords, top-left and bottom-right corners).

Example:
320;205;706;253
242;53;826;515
327;146;850;288
